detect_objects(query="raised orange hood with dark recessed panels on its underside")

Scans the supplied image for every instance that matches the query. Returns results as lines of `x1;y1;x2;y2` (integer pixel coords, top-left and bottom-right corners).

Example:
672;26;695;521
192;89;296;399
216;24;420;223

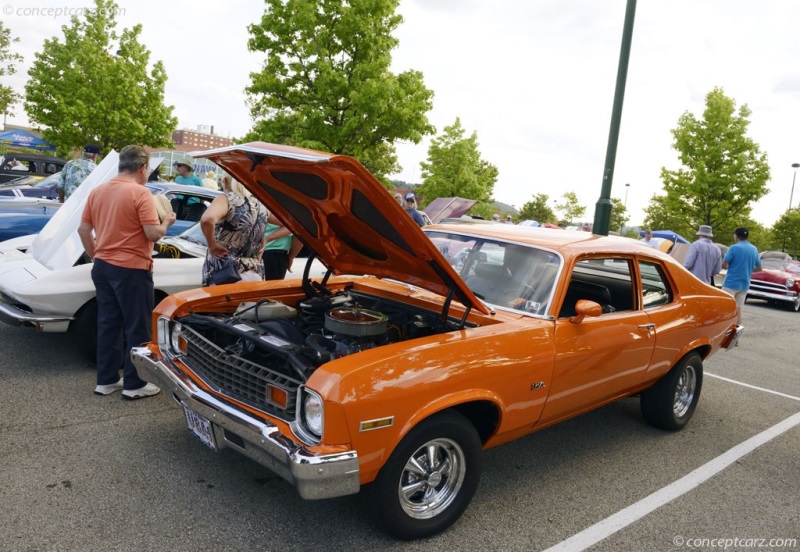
190;142;488;313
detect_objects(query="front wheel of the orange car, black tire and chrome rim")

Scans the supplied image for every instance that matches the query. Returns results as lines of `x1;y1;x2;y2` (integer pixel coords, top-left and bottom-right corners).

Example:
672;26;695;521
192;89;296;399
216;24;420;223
371;411;482;540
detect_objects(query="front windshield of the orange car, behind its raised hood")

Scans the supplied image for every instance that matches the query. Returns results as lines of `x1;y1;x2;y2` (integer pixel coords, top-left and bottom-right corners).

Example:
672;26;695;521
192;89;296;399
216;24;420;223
426;231;561;316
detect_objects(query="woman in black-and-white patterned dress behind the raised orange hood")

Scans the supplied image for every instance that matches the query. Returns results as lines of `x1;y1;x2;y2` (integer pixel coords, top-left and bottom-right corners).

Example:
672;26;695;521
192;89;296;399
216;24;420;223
200;176;276;286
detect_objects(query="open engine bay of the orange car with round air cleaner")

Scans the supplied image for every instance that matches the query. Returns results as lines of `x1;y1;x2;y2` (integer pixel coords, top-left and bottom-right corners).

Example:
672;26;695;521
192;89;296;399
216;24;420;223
176;289;462;382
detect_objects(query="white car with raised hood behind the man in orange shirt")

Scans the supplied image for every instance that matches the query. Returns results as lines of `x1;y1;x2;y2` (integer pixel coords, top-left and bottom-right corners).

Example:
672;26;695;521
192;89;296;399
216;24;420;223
0;154;327;359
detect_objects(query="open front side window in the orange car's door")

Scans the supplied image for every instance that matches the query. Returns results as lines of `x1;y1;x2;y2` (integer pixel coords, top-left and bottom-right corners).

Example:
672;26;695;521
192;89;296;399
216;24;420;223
558;258;633;318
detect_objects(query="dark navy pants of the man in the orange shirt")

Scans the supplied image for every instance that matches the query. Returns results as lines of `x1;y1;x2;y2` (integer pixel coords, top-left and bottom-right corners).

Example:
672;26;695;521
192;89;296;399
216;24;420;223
92;259;153;389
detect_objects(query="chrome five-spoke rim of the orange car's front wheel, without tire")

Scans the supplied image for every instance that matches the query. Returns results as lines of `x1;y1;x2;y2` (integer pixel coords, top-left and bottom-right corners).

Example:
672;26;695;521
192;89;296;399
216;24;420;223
397;439;467;519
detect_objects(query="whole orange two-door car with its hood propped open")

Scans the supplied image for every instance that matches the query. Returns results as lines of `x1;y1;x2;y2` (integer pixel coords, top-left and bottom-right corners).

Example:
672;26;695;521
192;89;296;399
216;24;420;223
131;142;741;539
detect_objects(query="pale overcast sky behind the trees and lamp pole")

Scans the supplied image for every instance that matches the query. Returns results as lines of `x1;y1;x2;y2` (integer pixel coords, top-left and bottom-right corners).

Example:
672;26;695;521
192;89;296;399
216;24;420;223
0;0;800;229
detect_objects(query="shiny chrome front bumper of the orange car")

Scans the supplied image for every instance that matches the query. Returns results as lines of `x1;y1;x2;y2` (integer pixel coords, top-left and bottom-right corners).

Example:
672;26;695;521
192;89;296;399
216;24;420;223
131;347;360;500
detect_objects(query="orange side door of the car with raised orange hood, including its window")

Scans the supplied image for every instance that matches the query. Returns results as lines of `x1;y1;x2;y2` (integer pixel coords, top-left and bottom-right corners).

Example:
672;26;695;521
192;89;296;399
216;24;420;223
542;257;655;423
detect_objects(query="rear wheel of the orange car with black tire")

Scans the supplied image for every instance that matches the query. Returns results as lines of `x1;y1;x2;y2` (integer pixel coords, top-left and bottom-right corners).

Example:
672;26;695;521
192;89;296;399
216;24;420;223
641;353;703;431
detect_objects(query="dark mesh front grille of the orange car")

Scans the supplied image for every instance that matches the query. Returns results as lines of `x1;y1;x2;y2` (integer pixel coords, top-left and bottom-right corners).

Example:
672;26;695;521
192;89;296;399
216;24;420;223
181;325;302;422
